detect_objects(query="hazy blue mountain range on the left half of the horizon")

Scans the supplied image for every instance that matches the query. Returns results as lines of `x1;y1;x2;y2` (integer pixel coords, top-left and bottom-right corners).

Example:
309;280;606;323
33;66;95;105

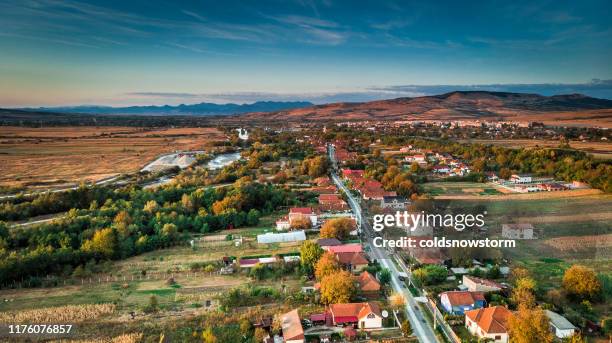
18;101;312;116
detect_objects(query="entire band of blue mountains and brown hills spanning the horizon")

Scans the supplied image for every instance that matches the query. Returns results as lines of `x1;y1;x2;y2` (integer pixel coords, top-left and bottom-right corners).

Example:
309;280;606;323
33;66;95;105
0;91;612;128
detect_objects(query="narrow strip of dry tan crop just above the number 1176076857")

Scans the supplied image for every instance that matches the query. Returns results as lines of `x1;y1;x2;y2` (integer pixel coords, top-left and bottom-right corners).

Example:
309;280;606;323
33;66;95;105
0;304;115;323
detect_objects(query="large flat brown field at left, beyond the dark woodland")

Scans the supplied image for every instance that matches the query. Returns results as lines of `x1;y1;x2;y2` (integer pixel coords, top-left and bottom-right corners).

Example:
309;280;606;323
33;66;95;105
0;127;225;188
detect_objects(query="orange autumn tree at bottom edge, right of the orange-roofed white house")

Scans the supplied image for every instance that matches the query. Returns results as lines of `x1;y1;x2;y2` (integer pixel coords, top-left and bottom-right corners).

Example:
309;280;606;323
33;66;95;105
508;306;554;343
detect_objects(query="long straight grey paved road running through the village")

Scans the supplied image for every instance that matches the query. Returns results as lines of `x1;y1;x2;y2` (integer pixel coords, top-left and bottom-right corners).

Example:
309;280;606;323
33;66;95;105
328;145;439;343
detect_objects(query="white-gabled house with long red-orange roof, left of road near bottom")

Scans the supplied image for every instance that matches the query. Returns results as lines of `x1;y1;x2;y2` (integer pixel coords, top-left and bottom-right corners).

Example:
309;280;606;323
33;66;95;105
328;302;382;329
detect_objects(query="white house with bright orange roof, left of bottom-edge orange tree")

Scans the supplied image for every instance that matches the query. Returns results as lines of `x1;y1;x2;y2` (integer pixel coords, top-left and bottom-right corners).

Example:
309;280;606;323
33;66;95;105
465;306;512;343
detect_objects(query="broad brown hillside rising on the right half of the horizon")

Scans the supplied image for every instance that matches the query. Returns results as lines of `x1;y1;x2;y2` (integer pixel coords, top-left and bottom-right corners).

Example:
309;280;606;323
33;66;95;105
243;91;612;127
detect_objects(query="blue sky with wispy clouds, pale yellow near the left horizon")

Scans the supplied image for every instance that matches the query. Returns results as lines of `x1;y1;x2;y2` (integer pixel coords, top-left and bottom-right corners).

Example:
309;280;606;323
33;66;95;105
0;0;612;107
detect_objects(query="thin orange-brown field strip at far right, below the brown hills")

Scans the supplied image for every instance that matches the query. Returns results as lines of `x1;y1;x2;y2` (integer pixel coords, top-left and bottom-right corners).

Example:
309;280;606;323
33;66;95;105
462;139;612;159
